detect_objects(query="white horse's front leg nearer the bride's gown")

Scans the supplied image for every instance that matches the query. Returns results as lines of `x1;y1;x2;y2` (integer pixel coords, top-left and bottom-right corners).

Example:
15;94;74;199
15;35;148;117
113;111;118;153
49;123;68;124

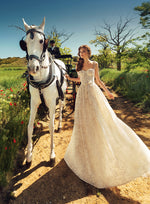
49;104;56;166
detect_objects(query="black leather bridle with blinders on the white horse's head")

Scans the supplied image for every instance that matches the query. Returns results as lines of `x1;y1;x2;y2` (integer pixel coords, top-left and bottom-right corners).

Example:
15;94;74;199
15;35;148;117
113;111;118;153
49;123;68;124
19;28;48;67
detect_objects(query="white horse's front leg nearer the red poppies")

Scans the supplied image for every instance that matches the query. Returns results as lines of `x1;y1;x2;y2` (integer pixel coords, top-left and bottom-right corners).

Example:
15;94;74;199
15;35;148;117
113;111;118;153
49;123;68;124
27;100;39;166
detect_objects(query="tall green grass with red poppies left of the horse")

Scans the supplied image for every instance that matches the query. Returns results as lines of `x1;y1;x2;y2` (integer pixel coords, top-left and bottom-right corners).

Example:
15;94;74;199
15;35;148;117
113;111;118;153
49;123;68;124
0;71;29;186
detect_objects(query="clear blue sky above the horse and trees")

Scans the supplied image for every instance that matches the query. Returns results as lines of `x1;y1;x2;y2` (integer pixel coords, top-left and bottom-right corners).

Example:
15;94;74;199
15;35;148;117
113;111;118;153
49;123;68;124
0;0;147;58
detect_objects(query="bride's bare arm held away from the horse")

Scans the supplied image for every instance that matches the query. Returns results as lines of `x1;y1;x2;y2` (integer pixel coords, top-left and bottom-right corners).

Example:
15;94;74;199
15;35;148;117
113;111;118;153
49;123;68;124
94;62;114;99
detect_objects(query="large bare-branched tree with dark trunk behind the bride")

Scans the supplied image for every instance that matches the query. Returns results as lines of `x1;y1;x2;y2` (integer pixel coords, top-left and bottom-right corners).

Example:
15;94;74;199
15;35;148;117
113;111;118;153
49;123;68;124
95;18;133;70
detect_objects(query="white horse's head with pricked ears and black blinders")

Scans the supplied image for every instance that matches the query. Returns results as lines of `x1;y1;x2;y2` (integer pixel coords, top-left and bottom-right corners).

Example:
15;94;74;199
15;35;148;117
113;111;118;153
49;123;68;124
20;18;48;75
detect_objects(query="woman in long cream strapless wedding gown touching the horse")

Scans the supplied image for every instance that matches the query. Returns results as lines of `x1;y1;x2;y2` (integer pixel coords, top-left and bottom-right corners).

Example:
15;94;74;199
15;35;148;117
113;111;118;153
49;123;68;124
64;45;150;188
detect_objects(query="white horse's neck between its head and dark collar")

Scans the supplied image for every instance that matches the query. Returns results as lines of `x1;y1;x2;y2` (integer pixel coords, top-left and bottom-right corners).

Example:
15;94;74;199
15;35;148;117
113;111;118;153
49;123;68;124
34;51;50;82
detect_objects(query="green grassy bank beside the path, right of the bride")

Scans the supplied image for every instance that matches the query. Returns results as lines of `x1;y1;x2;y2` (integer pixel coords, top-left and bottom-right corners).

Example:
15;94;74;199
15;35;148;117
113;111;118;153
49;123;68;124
100;69;150;111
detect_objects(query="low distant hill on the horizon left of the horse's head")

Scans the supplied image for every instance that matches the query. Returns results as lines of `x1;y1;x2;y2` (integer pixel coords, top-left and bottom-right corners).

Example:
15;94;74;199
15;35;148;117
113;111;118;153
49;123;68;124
0;57;27;67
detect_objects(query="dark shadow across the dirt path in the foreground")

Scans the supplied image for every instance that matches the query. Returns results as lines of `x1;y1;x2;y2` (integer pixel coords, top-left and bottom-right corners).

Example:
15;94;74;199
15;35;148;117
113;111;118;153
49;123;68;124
7;160;140;204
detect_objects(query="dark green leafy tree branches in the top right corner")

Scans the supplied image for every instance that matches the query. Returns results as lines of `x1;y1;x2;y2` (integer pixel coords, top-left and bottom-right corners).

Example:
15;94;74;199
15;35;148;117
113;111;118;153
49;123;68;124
134;1;150;28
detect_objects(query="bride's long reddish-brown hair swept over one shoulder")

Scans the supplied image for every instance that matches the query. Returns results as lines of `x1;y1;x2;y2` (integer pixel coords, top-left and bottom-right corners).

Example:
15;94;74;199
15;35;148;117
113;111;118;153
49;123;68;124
77;45;91;71
